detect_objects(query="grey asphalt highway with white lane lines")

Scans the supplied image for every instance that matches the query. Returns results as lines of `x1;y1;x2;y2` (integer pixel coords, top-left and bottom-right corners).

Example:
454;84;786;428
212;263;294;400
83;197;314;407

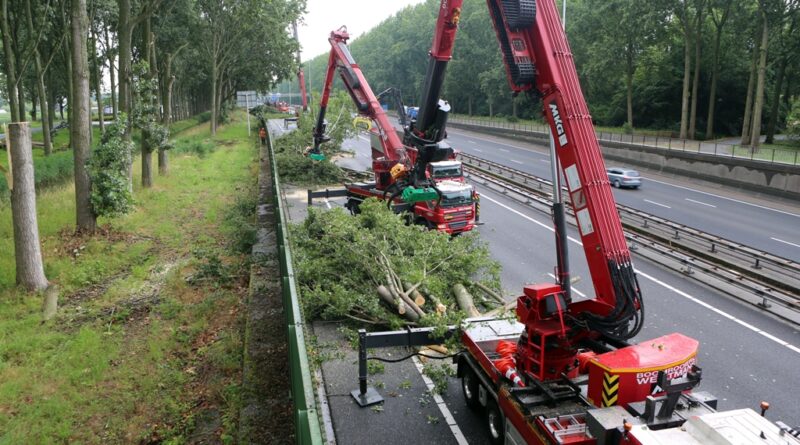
276;119;800;444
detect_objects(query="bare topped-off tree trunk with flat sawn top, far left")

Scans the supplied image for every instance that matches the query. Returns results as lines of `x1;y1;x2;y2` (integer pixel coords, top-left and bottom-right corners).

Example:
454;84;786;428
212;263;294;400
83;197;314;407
7;122;48;291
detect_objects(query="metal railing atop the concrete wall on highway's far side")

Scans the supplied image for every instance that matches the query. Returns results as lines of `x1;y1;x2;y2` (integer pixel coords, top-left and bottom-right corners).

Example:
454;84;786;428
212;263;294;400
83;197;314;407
448;115;800;165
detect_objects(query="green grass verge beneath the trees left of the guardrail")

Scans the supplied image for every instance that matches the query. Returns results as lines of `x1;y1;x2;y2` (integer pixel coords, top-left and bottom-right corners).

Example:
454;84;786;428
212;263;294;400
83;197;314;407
0;110;257;444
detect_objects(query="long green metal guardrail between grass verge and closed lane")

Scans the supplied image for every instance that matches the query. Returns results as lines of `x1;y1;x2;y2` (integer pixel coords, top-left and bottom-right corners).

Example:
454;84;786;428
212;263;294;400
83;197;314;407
267;127;324;445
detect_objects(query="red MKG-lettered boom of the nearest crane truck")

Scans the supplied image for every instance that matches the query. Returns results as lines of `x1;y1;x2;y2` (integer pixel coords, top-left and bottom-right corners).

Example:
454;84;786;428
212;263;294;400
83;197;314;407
487;0;641;338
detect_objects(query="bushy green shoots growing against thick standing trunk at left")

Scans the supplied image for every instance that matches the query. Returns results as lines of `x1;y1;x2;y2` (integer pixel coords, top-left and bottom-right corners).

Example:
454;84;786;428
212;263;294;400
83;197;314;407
88;113;133;217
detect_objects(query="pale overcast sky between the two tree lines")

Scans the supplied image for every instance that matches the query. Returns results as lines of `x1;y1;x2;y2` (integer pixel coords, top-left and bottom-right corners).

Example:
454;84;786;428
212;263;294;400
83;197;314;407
297;0;424;62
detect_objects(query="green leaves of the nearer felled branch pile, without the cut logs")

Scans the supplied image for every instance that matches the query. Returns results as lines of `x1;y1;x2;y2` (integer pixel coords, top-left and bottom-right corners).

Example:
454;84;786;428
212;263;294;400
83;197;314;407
292;199;499;327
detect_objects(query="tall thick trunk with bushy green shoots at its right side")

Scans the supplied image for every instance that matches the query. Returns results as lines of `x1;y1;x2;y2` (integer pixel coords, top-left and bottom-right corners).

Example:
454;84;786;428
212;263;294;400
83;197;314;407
69;0;97;233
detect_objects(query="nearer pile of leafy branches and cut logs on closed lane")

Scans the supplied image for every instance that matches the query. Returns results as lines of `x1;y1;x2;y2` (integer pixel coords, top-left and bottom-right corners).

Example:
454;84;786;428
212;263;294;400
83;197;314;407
292;199;503;328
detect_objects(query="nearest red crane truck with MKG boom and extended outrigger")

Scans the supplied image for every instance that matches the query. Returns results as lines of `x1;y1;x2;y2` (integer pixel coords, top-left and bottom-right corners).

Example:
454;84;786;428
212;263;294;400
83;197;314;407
352;0;800;445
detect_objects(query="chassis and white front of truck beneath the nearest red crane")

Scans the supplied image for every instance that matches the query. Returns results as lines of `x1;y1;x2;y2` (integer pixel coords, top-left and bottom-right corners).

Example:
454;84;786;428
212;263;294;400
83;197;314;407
453;318;800;445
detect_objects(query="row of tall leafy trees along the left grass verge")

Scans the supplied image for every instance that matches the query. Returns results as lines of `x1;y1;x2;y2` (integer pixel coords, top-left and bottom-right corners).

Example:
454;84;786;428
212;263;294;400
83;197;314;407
0;0;305;289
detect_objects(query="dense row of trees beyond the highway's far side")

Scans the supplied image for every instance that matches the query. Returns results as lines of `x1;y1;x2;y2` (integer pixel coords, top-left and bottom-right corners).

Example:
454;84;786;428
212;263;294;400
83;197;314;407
306;0;800;145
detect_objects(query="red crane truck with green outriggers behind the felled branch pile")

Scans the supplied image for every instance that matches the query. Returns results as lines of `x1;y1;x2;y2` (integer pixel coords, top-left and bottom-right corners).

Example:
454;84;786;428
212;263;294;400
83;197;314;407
307;27;477;235
